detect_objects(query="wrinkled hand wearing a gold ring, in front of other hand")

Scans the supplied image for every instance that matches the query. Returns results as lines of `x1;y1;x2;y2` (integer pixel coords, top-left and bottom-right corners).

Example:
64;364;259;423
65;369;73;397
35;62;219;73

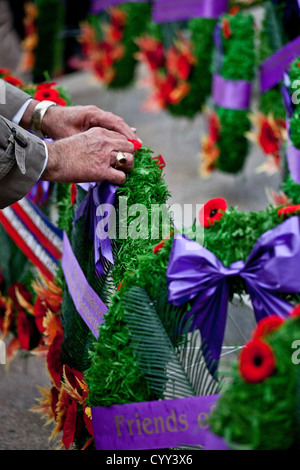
42;127;134;185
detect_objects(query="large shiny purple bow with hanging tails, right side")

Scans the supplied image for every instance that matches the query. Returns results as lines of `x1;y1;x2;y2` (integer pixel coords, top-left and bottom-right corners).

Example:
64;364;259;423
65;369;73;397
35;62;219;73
167;216;300;363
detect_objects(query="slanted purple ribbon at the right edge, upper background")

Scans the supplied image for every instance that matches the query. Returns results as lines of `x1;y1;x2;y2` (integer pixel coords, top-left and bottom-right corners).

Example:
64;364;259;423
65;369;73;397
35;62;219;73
260;36;300;93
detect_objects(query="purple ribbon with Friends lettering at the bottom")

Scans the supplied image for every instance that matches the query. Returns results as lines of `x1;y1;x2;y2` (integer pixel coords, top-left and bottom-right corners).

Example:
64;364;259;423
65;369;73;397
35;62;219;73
92;395;229;450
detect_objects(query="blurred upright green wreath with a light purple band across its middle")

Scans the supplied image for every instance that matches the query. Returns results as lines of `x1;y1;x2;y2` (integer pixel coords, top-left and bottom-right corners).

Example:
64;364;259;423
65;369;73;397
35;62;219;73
200;9;255;177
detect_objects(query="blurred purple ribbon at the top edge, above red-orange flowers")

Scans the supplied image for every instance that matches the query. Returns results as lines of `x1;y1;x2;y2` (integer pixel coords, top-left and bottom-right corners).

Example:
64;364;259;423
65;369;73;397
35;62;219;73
152;0;228;23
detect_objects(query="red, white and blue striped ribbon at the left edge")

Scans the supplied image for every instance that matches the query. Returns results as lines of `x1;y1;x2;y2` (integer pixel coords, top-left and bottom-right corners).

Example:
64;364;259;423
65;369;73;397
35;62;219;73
0;197;63;280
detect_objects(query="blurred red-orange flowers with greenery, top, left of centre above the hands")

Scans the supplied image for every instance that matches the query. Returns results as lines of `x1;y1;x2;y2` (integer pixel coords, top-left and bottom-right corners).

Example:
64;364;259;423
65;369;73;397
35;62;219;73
77;3;150;88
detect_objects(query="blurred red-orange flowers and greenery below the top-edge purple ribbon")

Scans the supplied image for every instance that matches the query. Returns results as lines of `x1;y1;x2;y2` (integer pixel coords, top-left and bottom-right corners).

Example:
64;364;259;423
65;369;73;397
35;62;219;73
136;18;216;118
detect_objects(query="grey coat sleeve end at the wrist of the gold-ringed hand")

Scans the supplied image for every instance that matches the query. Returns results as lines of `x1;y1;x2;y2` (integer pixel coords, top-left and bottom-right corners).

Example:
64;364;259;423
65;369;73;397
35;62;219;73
0;116;46;209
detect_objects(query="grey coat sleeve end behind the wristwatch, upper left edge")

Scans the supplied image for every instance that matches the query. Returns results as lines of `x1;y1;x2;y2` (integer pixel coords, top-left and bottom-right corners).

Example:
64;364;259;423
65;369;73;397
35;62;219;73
0;79;31;120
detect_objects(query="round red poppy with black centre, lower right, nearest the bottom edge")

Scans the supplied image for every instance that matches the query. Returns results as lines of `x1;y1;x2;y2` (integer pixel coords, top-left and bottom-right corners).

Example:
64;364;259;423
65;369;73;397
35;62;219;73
239;339;275;384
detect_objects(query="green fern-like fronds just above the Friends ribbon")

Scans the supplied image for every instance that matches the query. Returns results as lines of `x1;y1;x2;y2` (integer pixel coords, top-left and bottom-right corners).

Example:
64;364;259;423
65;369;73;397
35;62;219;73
122;287;219;399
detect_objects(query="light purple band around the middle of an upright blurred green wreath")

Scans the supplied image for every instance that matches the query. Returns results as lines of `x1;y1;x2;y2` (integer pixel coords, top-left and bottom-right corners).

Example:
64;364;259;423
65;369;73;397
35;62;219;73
212;75;251;109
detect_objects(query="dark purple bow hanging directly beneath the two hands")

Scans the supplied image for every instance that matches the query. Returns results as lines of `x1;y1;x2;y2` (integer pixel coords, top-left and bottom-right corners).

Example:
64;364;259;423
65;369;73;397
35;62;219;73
75;181;118;275
